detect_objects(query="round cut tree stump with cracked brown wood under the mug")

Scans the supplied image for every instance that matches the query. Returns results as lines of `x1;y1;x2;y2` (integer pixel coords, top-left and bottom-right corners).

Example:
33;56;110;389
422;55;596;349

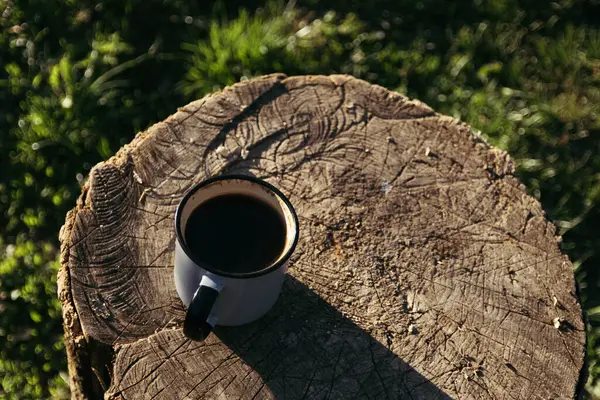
59;74;585;399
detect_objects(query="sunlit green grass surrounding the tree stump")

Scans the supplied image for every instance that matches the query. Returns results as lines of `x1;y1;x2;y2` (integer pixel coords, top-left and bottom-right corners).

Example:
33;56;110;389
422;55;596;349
0;0;600;399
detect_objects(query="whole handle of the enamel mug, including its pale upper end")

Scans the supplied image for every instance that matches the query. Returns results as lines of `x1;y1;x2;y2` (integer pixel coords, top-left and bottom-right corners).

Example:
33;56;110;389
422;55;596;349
183;274;223;341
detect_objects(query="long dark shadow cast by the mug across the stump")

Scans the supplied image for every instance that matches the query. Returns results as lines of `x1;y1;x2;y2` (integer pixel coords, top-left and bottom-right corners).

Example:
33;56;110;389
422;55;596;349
214;275;450;399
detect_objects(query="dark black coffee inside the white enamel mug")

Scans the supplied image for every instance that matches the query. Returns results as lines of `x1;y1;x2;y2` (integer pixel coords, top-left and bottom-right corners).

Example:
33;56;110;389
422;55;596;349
184;194;286;273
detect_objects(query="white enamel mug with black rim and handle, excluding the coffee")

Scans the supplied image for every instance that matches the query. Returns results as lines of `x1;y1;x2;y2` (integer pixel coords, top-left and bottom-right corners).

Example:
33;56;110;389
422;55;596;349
174;175;299;340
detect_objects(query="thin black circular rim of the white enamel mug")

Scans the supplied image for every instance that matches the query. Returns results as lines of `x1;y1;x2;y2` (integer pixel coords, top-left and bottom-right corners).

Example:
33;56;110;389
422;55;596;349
175;174;300;279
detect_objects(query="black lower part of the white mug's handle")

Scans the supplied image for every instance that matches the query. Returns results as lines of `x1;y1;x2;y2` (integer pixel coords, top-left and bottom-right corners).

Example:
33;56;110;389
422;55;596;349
183;285;219;341
